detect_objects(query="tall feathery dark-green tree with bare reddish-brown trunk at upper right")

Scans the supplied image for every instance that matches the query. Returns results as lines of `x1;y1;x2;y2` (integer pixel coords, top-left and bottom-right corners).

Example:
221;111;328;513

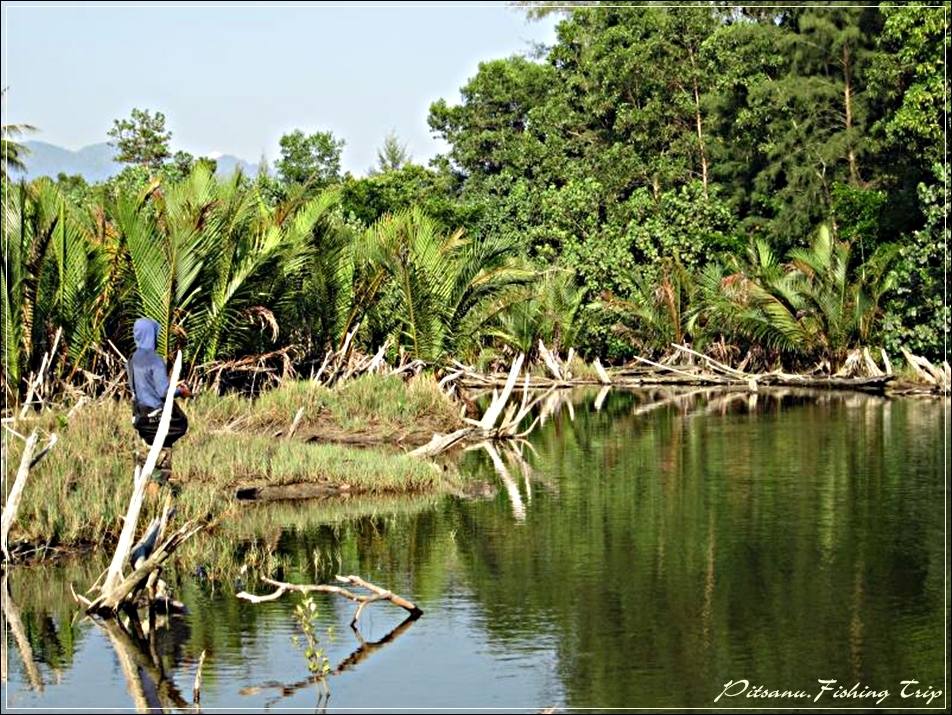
749;5;881;245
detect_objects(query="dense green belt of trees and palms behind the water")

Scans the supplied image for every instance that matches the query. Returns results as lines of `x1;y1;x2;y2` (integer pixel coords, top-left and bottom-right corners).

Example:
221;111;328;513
2;5;949;402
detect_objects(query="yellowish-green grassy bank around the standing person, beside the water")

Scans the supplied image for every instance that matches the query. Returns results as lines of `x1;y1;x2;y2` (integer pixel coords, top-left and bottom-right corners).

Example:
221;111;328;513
4;376;458;545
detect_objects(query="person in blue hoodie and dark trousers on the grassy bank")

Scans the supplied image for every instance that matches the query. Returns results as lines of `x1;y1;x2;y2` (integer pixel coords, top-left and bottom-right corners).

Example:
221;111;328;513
126;318;192;472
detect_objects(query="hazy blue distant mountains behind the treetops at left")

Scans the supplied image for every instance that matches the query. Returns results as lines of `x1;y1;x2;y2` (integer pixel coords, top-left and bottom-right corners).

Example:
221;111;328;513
23;141;258;183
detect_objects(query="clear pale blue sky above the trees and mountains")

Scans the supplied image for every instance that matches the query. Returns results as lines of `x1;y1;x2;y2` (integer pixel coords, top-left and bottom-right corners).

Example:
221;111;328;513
2;2;557;174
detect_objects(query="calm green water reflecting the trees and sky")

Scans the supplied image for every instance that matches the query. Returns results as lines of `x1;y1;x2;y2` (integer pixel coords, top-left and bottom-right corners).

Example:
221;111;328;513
3;391;949;710
